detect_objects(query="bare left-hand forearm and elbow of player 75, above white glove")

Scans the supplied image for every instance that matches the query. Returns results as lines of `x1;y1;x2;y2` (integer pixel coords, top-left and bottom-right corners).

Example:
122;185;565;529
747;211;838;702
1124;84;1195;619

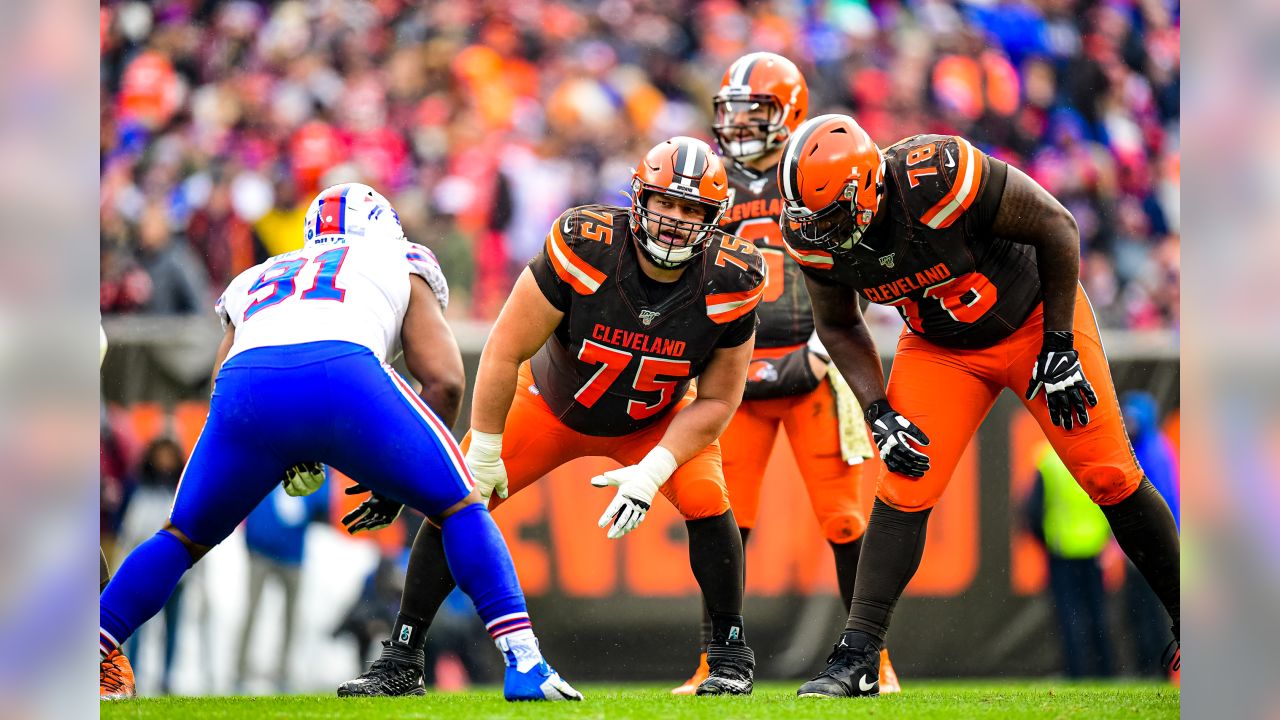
471;268;564;434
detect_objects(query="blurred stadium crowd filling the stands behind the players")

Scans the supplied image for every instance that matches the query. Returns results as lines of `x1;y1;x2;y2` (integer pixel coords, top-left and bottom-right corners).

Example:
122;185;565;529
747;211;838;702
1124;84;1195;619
100;0;1180;329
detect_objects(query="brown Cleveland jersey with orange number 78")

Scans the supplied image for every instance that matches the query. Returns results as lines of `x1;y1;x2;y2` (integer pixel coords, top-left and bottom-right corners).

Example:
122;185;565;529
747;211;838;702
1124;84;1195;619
783;135;1042;348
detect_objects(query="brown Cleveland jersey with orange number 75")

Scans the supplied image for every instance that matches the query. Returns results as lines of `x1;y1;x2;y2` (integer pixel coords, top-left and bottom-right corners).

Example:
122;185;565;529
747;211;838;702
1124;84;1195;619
529;205;765;437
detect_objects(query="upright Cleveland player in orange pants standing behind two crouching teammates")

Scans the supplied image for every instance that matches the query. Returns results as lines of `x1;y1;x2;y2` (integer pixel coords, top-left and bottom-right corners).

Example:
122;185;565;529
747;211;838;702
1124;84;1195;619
672;53;899;694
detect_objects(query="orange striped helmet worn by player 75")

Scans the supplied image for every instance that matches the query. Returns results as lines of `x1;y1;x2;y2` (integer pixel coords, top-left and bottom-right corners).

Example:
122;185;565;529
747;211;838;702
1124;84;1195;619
631;136;728;268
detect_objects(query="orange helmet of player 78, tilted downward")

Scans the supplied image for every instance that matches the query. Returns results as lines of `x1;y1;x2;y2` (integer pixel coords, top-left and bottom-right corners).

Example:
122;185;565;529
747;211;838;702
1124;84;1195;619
778;115;884;250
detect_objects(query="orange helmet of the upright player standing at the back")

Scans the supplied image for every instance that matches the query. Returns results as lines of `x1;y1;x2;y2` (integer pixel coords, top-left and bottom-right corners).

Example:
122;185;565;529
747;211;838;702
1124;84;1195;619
712;53;809;160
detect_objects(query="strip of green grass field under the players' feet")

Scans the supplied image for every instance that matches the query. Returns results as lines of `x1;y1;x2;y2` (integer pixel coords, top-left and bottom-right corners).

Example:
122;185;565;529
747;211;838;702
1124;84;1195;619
101;682;1179;720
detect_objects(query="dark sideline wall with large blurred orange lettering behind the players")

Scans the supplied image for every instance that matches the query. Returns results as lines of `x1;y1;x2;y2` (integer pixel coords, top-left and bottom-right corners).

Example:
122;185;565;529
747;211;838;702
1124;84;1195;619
104;318;1180;679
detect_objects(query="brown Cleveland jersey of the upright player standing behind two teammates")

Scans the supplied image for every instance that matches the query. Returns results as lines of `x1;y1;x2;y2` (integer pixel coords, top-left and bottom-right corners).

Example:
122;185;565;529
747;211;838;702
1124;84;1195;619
721;160;813;348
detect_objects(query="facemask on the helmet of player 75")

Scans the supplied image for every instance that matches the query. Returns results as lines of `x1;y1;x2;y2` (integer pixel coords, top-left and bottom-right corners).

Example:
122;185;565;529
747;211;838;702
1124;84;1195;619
631;178;728;269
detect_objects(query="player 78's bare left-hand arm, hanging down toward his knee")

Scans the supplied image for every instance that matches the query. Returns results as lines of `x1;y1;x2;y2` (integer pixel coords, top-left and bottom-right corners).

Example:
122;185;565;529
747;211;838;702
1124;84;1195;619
804;273;884;407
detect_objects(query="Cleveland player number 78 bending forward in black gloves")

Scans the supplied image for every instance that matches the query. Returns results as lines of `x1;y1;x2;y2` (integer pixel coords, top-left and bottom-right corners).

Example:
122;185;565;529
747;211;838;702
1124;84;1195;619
778;115;1179;697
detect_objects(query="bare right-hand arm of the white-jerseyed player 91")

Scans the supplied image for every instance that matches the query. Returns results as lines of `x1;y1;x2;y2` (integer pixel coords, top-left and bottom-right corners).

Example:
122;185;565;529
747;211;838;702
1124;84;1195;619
401;275;467;427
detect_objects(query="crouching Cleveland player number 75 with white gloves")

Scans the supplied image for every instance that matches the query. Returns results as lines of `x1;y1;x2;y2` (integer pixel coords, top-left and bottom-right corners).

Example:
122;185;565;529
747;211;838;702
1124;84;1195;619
338;137;765;696
